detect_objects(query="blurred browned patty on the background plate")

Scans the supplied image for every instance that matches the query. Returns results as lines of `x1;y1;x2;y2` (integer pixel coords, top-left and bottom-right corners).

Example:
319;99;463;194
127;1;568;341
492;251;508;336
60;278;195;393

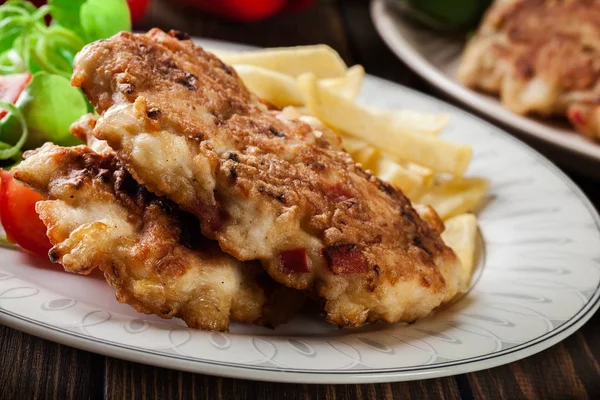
459;0;600;139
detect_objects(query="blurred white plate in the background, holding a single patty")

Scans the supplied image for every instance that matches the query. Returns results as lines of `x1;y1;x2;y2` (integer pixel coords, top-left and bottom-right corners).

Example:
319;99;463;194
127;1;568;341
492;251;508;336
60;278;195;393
371;0;600;164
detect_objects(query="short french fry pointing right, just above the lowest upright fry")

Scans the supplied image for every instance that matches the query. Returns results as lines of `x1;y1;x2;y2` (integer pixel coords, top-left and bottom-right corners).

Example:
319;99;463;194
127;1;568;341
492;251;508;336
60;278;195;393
411;178;489;221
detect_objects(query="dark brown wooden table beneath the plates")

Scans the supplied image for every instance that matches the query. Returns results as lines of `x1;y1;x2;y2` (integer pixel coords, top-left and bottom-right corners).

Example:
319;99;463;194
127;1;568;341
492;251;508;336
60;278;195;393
0;0;600;399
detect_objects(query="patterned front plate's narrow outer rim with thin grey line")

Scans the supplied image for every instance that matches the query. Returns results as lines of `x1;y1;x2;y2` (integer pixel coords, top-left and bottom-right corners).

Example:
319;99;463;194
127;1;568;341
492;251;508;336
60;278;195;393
0;63;600;384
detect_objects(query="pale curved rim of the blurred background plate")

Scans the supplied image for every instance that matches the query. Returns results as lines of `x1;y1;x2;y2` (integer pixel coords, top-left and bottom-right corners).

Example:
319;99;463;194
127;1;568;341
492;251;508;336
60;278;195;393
370;0;600;161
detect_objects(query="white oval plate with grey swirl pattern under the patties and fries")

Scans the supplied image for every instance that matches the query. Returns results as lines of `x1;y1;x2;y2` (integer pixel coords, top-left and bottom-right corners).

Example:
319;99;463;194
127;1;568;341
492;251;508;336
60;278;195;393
0;42;600;383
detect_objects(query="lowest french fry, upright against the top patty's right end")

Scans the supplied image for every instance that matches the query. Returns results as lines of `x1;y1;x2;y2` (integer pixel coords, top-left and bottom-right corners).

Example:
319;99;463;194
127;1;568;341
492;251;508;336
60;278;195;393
442;214;477;290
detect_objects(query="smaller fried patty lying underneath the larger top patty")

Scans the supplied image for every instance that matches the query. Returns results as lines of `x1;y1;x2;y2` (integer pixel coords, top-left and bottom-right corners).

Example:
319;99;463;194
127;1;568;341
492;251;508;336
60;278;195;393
14;144;301;331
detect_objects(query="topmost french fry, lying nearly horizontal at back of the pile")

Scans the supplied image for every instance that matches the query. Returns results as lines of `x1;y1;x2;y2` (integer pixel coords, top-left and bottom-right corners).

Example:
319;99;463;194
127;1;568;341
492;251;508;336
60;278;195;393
214;44;347;78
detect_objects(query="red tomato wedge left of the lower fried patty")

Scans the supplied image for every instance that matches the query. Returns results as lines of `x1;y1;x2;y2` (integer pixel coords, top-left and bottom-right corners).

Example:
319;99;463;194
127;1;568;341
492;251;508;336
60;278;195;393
0;170;52;258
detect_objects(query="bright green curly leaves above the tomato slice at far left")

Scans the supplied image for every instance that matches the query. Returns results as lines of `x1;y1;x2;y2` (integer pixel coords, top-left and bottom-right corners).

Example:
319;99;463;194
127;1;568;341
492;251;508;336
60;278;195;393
0;0;131;77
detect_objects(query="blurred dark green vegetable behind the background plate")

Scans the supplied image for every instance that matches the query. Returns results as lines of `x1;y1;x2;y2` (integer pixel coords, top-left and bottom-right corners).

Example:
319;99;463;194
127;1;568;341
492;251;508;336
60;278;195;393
395;0;492;31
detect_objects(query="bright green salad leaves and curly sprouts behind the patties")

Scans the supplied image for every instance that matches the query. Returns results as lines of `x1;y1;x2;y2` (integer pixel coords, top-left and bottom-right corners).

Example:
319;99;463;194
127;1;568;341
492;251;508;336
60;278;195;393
0;0;131;161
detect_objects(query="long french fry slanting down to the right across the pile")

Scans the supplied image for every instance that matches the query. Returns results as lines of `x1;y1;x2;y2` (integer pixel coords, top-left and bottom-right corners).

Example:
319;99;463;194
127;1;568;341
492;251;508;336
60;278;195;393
298;74;472;176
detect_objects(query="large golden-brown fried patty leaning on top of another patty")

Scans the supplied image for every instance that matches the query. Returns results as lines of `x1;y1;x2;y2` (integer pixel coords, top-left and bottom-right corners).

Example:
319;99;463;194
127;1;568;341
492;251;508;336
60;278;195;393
72;30;459;326
